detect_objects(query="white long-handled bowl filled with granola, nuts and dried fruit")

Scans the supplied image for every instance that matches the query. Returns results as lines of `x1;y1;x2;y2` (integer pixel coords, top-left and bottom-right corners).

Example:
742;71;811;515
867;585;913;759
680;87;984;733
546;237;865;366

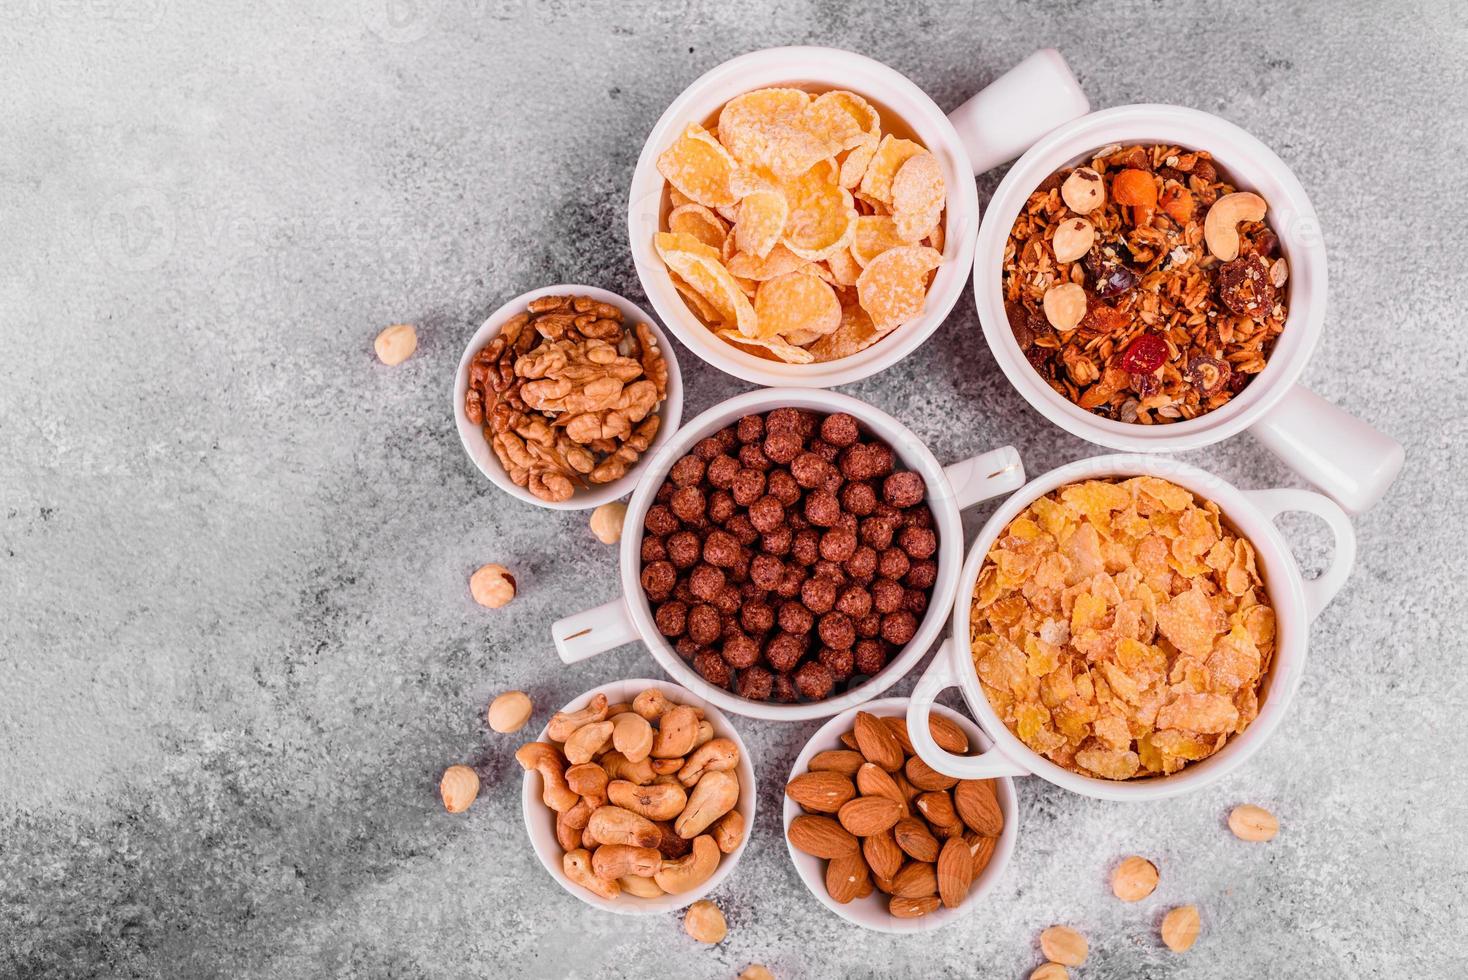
973;106;1402;512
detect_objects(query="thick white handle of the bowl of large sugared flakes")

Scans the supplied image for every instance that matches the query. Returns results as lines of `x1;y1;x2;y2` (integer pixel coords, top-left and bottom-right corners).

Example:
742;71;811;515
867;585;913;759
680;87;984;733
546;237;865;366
948;47;1091;175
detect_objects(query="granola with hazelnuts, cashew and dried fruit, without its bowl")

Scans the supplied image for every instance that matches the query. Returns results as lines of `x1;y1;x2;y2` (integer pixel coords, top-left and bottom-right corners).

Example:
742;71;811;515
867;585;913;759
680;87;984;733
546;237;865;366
1003;145;1289;424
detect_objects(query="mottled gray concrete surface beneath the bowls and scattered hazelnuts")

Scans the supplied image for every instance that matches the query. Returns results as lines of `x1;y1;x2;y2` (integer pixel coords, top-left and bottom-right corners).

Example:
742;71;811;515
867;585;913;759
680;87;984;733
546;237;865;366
0;0;1468;977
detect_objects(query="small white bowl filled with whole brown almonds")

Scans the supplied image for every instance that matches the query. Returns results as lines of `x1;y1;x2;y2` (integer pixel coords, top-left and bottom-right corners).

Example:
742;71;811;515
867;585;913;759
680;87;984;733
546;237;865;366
784;698;1019;933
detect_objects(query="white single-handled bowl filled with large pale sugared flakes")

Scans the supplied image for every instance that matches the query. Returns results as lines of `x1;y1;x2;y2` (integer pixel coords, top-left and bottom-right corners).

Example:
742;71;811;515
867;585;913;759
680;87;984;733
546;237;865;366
627;47;1089;387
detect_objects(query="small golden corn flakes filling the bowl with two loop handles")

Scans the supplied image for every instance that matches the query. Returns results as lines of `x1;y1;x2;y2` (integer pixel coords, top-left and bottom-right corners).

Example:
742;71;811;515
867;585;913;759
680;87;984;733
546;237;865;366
969;477;1274;779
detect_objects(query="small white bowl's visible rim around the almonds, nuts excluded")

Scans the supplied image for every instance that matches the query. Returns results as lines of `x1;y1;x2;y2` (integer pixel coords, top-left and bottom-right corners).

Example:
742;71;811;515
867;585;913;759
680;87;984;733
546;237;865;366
784;697;1019;933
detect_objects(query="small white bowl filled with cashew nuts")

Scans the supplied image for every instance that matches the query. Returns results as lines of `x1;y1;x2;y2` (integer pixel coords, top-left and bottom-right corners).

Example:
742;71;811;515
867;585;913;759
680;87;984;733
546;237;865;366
515;679;755;915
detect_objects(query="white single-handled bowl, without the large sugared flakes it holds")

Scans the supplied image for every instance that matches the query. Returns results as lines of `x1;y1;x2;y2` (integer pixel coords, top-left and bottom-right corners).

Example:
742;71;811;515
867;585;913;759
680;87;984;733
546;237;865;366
627;47;1091;387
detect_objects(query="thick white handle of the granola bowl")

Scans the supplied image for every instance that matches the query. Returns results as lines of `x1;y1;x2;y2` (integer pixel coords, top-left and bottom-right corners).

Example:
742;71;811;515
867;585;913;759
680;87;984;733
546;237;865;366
1249;384;1406;513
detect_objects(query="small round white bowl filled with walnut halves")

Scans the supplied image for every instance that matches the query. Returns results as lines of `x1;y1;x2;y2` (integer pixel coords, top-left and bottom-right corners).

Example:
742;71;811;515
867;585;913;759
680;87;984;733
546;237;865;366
454;285;683;511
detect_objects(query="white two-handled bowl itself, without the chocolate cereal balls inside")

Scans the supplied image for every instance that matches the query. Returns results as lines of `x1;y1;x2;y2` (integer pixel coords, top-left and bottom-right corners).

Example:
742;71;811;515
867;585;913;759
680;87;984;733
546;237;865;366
551;387;1025;722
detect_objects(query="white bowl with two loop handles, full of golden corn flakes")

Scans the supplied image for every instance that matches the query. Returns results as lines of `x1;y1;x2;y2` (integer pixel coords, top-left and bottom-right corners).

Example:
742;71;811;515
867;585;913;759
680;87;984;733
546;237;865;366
907;455;1355;800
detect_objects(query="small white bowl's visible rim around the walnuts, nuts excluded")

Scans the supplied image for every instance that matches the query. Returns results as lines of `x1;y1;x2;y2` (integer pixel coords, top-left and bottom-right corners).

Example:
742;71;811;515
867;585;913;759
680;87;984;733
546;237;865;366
454;285;683;511
